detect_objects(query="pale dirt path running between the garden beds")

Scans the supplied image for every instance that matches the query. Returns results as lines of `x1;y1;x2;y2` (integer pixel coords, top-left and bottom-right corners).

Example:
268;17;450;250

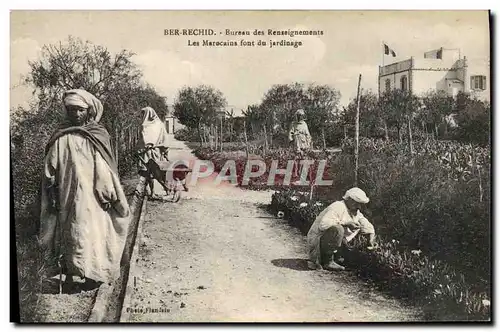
122;137;417;322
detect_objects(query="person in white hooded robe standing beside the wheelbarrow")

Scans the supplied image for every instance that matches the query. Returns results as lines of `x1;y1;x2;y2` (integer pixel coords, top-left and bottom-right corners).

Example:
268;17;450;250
138;106;168;199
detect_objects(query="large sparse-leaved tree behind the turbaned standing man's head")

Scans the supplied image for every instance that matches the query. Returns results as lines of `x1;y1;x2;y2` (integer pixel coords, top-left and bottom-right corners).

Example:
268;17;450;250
26;36;158;165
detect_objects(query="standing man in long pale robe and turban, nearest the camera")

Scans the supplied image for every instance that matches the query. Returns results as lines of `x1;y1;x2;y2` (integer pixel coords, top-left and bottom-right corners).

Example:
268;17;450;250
40;89;130;284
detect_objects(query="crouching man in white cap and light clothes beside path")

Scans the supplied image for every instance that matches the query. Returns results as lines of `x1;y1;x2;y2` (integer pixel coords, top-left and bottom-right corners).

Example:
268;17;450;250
307;187;375;271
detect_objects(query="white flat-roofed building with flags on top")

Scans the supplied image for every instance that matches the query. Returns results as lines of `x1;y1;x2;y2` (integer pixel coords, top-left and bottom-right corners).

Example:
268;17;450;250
378;48;490;101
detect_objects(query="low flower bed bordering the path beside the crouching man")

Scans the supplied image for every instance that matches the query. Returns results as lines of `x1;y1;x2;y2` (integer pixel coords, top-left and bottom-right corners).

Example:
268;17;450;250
269;190;490;321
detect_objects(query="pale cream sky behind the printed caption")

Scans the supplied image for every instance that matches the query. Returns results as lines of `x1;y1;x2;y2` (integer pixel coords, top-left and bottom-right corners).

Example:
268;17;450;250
10;11;490;114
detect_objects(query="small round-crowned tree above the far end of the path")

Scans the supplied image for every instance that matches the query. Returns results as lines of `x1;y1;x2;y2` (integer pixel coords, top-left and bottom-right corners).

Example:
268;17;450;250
174;85;227;144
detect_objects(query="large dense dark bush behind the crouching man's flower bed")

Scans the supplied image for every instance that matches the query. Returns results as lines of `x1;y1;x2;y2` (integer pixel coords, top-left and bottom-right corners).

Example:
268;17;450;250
332;142;491;283
